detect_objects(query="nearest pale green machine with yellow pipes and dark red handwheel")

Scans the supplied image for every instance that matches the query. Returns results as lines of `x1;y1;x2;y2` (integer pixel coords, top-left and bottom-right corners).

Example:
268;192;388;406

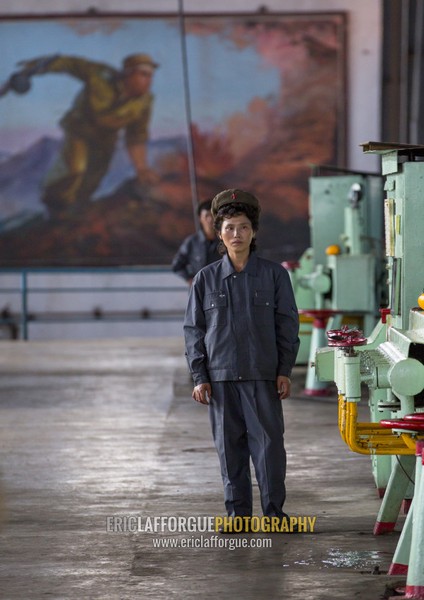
315;142;424;504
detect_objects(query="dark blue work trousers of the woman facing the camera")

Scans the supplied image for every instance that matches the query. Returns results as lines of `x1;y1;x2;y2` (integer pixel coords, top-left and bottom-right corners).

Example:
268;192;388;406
209;381;286;518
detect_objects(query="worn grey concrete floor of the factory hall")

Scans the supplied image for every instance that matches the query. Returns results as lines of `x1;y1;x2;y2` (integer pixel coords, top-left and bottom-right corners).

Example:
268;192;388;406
0;339;404;600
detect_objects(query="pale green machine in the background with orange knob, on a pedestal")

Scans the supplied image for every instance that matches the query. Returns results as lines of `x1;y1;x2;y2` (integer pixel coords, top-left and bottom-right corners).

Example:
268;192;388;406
285;167;387;396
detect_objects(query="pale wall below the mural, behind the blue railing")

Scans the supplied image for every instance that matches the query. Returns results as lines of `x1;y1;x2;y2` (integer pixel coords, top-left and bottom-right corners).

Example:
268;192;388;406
0;267;189;340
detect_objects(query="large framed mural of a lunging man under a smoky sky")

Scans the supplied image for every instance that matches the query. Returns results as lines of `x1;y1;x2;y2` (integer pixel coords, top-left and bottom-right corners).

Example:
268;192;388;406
0;13;346;266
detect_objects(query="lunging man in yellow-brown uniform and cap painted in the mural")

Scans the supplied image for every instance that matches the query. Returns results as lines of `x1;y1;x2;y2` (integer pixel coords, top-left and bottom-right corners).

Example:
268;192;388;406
10;54;159;215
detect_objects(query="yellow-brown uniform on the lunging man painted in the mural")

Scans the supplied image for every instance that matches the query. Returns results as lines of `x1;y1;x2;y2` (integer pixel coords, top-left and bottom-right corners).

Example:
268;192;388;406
25;56;153;211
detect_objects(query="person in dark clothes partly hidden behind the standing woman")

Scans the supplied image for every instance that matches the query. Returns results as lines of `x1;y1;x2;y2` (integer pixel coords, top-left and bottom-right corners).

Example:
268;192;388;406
171;199;221;285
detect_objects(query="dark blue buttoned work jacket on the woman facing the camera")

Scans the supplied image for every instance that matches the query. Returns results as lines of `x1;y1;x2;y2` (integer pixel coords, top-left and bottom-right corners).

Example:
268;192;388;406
184;252;299;385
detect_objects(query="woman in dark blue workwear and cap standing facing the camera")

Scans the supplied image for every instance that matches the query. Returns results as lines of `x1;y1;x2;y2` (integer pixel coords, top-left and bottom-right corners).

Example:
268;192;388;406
184;189;299;520
